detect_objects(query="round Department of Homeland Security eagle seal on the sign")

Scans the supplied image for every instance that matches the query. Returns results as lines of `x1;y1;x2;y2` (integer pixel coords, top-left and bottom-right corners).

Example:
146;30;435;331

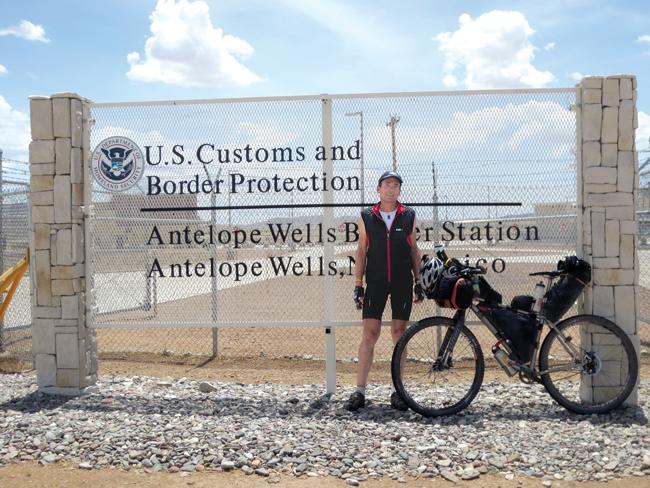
91;136;144;192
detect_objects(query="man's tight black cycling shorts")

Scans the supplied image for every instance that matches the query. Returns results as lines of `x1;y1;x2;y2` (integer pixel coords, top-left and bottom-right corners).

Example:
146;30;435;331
362;280;413;320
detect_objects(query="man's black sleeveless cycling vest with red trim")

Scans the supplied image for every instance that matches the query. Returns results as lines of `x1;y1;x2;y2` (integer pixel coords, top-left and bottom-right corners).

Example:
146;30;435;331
361;203;415;283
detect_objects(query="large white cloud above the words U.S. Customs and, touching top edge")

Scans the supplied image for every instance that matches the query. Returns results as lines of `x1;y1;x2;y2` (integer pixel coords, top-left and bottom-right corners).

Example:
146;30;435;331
126;0;263;86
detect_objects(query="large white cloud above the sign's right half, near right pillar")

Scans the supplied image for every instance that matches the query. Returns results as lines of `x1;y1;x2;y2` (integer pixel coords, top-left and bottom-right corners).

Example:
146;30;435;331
435;10;555;89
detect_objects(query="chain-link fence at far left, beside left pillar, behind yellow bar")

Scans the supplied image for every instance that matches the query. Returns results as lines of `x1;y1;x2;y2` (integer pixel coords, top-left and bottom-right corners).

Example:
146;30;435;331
0;151;32;361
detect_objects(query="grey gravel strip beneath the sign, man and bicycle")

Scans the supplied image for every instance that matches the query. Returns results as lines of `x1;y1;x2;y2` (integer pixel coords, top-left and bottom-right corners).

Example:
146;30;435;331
0;375;650;485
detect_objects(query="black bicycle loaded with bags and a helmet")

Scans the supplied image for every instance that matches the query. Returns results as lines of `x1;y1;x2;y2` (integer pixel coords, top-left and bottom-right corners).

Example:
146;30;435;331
391;249;638;417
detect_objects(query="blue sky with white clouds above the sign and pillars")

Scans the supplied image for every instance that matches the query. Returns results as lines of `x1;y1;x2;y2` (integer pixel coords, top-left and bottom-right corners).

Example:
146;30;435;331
0;0;650;159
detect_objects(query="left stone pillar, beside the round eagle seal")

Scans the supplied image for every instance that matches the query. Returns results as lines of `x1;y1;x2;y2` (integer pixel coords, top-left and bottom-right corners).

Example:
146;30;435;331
29;93;97;395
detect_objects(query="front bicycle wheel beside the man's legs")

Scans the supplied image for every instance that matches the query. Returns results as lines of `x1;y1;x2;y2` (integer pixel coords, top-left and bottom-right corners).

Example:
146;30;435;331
391;317;485;417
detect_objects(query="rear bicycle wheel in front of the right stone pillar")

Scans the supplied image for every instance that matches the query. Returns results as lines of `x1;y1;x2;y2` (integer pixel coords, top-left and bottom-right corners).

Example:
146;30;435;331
539;315;639;414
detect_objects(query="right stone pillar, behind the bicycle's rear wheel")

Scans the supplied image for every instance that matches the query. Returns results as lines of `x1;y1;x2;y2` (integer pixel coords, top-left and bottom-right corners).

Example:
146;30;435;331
578;75;640;405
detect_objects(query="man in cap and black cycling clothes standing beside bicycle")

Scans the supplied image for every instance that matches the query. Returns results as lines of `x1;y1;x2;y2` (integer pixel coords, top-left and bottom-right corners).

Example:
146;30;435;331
345;171;424;410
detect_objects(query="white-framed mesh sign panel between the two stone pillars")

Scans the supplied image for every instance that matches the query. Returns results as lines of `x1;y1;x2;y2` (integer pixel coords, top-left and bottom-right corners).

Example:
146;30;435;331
89;89;576;366
